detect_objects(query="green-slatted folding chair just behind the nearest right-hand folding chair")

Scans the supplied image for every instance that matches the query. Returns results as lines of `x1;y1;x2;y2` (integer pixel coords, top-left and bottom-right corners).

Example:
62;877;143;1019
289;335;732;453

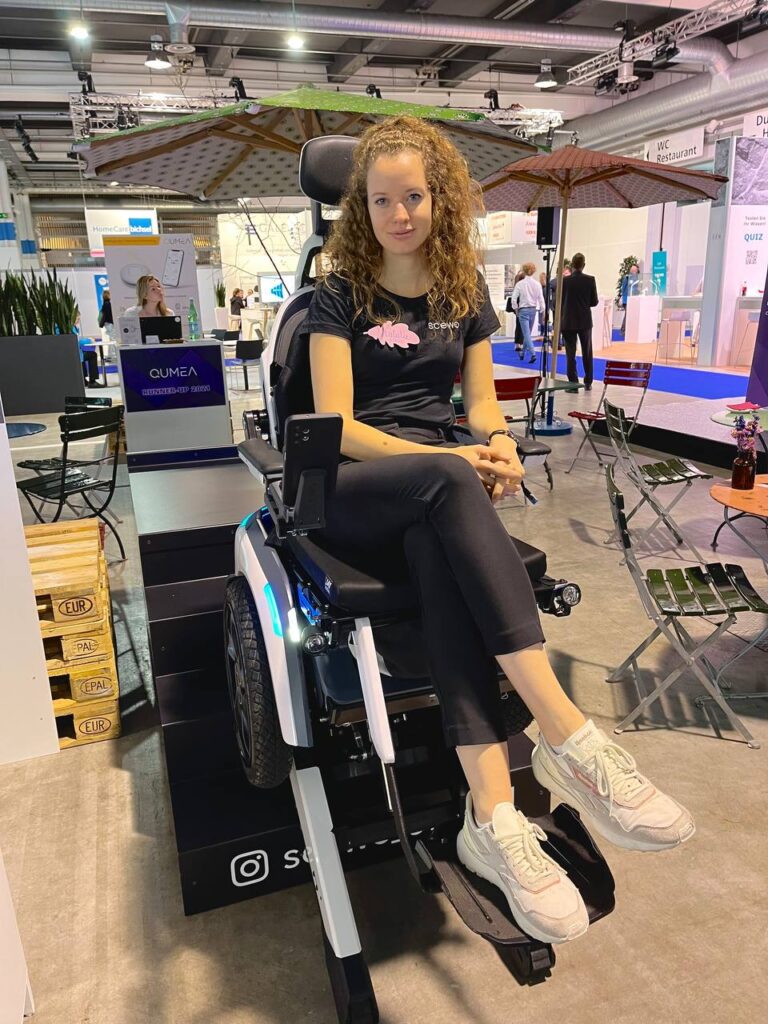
603;398;712;562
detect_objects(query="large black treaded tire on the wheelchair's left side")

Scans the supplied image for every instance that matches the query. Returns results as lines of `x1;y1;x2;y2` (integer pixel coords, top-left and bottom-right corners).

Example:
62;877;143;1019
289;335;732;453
224;577;293;790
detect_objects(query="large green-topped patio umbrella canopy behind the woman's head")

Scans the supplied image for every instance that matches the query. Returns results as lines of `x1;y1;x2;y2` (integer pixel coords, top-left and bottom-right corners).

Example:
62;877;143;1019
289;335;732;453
73;87;538;200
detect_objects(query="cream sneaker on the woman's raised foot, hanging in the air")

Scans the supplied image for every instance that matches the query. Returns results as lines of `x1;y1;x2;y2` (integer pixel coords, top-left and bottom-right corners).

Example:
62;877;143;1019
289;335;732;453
531;720;696;850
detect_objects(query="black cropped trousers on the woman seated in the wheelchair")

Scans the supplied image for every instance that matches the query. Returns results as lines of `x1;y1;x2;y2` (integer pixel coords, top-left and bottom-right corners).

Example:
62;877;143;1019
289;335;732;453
324;453;544;745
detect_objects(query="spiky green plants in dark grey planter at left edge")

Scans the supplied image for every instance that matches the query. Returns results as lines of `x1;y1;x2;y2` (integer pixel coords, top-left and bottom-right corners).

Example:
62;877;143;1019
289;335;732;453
0;270;85;416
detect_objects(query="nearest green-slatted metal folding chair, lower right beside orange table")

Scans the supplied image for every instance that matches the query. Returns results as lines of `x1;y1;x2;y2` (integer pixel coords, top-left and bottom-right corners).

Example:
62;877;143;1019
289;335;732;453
605;466;768;749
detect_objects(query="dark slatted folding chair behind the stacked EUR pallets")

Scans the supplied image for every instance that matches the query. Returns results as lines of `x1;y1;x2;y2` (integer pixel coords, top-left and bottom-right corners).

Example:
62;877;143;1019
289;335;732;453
16;406;125;560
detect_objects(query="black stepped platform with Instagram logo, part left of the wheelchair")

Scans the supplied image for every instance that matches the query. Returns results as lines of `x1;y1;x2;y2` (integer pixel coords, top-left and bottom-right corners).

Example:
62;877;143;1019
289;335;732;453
130;461;310;913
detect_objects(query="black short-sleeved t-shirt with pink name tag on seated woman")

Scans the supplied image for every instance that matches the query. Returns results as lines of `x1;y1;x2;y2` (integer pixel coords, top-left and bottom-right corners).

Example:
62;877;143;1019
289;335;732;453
303;273;499;439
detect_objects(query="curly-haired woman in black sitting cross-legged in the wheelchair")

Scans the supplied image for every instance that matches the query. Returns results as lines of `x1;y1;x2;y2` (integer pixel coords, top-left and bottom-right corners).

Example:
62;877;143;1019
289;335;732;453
306;117;694;943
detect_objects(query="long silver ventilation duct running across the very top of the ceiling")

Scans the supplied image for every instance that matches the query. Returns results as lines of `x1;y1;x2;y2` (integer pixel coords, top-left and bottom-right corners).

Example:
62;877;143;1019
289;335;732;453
0;0;733;73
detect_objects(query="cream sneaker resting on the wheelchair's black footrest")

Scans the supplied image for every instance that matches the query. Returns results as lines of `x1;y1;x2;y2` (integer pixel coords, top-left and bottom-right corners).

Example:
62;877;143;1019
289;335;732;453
456;794;589;942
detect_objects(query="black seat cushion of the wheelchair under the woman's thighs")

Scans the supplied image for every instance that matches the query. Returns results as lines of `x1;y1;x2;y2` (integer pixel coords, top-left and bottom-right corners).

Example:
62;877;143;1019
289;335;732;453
287;537;547;615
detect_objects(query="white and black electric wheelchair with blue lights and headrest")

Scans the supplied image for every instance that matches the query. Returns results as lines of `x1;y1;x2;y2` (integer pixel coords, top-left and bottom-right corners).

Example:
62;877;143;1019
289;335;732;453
224;136;613;1024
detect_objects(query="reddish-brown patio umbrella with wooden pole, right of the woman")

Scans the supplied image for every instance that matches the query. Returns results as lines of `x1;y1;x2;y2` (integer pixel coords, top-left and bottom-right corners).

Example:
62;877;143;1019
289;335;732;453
482;144;728;377
